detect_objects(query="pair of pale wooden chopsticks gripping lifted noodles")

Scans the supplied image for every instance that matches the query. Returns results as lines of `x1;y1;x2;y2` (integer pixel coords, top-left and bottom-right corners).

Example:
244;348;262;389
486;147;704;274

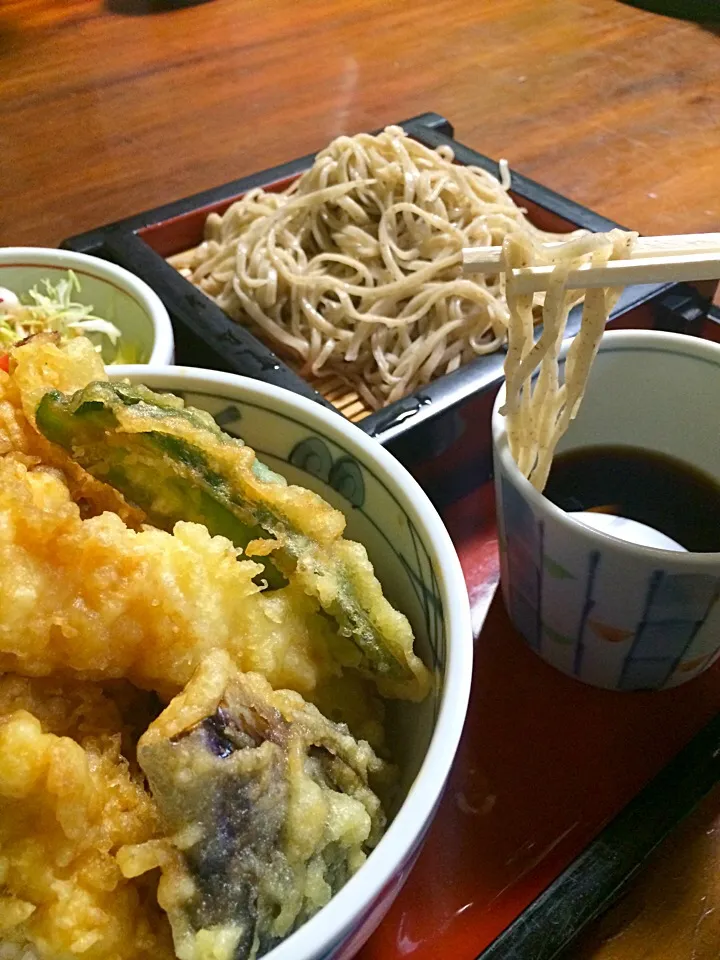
463;233;720;293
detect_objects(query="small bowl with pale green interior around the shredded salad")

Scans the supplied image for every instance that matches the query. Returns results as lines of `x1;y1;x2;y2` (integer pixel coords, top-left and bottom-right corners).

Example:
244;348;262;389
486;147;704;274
0;247;175;364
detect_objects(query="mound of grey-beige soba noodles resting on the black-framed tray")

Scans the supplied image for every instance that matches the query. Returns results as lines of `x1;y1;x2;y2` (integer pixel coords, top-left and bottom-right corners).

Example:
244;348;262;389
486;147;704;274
175;127;584;409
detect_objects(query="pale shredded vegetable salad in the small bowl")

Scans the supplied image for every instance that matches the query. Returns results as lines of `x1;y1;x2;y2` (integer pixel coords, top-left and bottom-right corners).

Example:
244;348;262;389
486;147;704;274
0;270;120;352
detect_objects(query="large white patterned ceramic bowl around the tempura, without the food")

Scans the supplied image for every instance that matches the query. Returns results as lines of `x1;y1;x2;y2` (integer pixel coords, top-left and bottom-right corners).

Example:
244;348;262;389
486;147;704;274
108;365;473;960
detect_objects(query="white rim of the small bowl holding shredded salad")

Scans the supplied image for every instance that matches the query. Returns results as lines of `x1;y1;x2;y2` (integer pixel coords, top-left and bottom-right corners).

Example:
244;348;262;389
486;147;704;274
0;247;174;369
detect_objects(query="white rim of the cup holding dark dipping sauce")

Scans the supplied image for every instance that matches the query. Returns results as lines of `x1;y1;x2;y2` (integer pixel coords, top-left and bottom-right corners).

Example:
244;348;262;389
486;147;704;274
492;330;720;571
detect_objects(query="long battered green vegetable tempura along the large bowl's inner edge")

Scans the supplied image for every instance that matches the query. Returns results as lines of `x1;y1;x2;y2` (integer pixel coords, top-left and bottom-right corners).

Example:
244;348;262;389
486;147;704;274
13;340;431;700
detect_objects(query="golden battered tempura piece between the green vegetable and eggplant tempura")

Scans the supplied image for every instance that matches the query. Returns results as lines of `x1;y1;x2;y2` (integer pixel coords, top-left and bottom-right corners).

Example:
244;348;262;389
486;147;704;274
0;455;342;697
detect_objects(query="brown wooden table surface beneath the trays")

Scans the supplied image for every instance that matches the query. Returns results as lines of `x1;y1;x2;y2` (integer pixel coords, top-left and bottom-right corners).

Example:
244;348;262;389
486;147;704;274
0;0;720;960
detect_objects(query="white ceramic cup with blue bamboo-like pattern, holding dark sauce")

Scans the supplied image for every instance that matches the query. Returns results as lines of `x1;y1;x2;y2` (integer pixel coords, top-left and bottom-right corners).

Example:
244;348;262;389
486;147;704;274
492;331;720;690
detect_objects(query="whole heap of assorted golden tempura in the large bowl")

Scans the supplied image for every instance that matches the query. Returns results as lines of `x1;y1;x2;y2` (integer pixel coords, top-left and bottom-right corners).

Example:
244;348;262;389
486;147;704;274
0;335;430;960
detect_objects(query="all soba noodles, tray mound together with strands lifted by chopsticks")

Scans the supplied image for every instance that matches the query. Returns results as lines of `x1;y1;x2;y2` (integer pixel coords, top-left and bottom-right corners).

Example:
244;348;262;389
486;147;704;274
173;127;635;490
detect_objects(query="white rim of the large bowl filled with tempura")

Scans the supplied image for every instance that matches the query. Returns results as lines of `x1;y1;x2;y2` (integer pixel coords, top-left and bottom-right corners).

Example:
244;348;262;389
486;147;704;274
114;365;473;960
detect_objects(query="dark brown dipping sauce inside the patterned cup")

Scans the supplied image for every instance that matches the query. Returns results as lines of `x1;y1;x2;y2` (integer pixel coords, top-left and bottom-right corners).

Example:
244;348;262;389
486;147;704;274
543;447;720;553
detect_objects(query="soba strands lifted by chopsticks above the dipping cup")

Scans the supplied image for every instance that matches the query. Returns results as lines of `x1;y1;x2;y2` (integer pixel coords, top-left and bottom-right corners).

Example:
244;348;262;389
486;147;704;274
500;230;637;490
